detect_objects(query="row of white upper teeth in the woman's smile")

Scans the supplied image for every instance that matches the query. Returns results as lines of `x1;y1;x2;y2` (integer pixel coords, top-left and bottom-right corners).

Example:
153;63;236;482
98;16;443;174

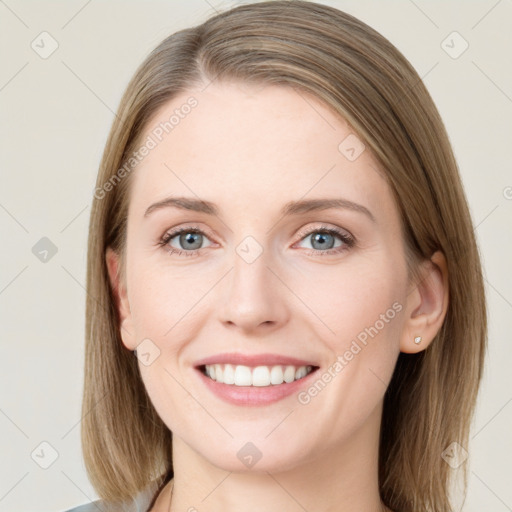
205;364;313;387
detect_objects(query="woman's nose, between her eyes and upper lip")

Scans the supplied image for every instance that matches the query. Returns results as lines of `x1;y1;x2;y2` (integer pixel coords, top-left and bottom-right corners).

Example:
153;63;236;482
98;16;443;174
219;245;291;333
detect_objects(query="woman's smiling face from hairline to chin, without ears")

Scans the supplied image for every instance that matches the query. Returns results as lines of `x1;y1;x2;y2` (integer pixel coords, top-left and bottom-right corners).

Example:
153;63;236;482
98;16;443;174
108;83;408;471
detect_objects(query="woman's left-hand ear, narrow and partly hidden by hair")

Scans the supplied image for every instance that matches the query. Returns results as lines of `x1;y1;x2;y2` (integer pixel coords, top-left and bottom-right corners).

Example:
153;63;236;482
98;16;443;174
105;247;137;350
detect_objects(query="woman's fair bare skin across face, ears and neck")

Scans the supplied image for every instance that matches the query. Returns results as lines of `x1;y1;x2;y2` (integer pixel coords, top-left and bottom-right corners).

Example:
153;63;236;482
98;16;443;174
106;82;448;512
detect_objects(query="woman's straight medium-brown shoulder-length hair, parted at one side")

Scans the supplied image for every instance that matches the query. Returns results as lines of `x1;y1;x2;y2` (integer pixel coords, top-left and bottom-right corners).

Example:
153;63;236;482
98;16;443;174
82;0;487;512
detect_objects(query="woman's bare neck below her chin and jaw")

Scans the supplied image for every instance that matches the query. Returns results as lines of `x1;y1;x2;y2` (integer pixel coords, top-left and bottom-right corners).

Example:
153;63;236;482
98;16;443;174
162;404;389;512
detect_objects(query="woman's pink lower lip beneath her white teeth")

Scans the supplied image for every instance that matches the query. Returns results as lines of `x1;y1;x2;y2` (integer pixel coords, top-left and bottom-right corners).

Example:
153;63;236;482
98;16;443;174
195;368;318;405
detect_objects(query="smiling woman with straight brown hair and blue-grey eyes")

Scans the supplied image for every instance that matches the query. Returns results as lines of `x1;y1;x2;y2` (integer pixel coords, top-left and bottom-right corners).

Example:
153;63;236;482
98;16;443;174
66;1;486;512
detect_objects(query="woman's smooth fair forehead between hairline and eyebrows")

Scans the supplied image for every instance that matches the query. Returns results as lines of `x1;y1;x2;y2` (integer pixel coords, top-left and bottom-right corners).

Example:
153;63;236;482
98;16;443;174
130;82;391;220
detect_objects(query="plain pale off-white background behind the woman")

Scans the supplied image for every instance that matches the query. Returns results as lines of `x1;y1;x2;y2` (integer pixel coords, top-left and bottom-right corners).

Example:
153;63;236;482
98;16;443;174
0;0;512;512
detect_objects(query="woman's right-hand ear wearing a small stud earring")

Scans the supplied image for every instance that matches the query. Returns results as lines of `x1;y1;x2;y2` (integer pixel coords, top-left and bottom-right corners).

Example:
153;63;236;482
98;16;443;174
400;251;449;354
